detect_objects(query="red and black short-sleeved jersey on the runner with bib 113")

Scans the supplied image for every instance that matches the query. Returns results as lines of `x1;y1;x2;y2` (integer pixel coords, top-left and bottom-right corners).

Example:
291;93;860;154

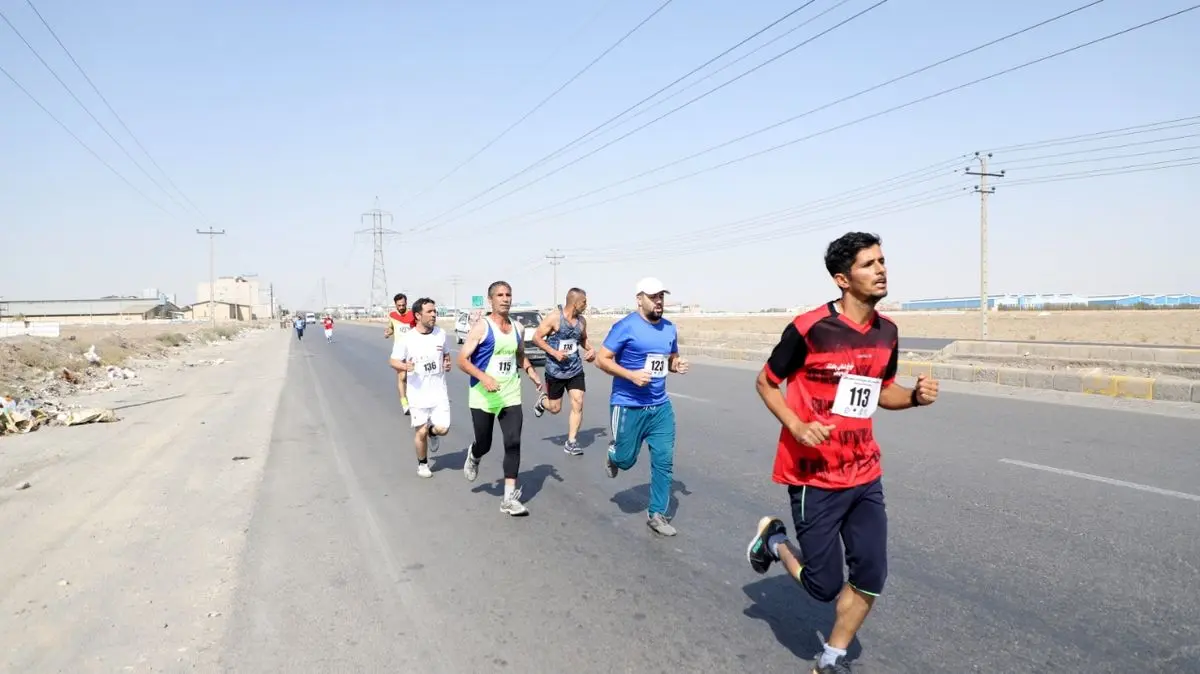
763;302;900;489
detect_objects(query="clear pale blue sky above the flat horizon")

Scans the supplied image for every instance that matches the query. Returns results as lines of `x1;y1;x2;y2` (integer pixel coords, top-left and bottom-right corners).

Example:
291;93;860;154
0;0;1200;311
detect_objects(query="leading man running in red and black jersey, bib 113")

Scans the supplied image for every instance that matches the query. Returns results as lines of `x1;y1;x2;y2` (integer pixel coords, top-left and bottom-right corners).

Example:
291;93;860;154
746;231;937;674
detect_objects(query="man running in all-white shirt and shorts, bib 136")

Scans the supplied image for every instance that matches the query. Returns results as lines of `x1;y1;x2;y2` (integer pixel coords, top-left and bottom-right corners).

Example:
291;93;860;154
389;297;450;477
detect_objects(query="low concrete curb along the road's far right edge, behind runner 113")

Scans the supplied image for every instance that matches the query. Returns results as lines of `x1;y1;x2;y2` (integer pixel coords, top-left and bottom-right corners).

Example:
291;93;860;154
679;344;1200;403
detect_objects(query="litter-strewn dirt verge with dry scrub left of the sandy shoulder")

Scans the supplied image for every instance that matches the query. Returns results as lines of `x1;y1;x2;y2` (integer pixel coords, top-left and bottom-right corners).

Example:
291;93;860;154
0;324;259;398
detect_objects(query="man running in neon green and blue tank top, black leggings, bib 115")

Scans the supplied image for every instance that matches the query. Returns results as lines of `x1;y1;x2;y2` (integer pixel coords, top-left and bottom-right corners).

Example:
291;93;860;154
458;281;541;517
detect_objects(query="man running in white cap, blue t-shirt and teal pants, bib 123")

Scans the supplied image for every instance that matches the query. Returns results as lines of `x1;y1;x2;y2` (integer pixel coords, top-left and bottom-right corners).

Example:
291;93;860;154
596;278;688;536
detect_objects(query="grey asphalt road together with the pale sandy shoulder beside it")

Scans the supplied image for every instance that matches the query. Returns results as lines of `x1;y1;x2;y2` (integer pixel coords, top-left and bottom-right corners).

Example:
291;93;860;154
0;323;1200;674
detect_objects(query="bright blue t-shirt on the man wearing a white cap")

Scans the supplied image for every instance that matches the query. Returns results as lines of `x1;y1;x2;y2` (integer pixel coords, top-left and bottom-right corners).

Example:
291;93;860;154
604;312;679;408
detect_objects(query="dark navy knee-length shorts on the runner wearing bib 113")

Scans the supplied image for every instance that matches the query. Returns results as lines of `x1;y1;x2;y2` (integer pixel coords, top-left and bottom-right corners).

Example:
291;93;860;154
787;479;888;602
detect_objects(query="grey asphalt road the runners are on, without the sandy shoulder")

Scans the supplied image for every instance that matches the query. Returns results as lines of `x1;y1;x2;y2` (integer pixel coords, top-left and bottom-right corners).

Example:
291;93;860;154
222;323;1200;674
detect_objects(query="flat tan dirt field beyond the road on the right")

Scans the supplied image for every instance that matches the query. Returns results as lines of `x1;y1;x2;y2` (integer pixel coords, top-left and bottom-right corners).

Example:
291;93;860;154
592;309;1200;347
